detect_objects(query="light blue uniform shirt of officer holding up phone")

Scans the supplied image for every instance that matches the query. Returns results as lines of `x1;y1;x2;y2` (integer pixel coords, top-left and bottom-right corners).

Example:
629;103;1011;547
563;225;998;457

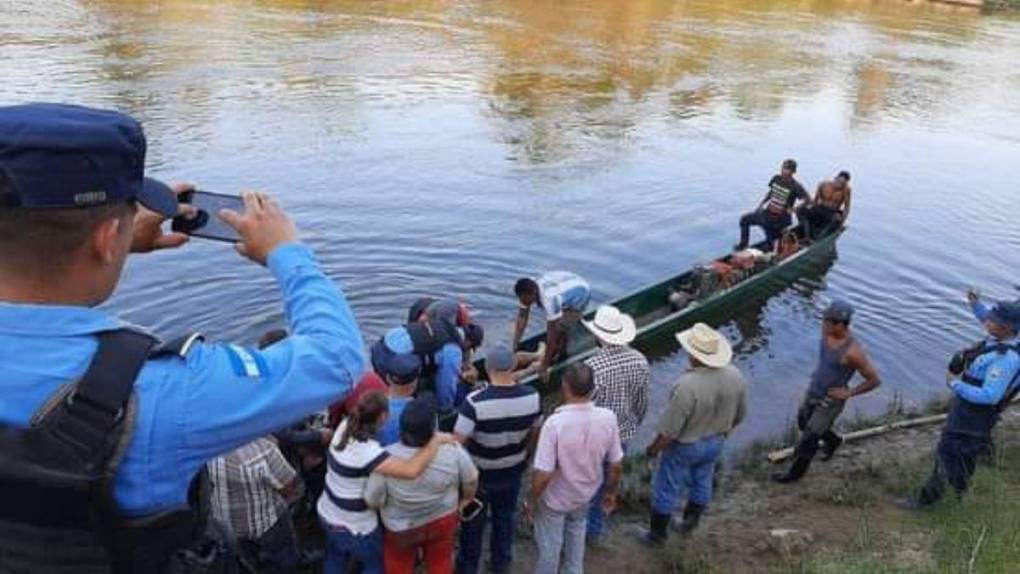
0;244;364;516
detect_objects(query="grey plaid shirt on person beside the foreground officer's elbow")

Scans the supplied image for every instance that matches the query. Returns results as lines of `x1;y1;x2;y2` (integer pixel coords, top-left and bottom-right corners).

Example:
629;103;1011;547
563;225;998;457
207;438;298;540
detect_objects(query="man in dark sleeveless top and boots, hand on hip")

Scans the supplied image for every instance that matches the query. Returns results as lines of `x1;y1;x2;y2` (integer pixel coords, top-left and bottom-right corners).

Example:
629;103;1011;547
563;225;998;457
772;301;881;482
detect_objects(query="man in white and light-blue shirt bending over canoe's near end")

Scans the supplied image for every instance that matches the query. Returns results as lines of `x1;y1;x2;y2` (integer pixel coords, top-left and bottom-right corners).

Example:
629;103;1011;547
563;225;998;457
513;271;592;380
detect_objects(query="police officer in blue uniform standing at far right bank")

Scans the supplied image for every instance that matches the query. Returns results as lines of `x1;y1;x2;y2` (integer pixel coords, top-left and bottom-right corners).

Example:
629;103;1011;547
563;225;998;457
905;291;1020;509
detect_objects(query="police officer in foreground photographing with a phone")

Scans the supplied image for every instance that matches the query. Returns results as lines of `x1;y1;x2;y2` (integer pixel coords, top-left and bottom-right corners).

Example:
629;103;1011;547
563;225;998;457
0;104;364;573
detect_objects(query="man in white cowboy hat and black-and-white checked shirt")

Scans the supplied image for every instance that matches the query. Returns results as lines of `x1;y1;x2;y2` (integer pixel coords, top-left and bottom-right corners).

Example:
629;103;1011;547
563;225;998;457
582;305;652;546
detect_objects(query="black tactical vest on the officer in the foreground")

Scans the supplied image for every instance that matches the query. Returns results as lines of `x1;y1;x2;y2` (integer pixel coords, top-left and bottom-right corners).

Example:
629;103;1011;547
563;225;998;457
0;329;156;574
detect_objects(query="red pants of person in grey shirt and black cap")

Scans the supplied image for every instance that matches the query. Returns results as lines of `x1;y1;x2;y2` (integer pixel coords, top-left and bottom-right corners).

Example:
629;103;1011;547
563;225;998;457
383;512;460;574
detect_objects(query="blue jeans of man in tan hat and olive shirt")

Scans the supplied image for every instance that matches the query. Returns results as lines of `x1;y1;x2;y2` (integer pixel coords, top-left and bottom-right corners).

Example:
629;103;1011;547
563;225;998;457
652;434;725;514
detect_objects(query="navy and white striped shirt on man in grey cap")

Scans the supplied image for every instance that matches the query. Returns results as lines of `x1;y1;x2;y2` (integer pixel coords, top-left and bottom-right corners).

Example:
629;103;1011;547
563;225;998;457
454;384;542;479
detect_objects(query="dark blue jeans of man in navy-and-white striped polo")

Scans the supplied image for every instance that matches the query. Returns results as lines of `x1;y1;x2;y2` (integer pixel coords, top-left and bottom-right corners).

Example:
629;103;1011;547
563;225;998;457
457;471;521;574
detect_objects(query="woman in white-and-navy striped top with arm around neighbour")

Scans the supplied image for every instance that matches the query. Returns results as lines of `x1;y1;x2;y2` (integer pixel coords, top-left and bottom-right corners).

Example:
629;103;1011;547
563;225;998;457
318;392;452;574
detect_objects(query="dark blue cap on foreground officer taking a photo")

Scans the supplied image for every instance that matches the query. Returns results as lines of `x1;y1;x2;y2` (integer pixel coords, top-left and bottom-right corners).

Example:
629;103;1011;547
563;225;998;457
0;104;177;217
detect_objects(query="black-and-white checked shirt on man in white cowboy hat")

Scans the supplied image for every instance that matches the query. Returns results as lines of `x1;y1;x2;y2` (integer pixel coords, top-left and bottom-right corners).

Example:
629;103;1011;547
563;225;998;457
584;345;652;443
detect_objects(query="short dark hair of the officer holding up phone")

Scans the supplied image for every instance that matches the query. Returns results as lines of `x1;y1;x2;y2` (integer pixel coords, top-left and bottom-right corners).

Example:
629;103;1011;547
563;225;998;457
0;192;135;272
